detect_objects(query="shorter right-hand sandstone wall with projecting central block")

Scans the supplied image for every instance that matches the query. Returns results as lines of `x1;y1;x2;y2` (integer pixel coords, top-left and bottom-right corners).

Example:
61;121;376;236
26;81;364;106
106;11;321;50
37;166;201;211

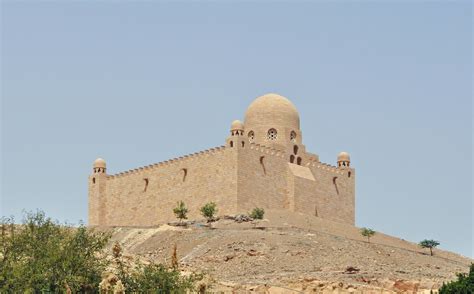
237;144;355;224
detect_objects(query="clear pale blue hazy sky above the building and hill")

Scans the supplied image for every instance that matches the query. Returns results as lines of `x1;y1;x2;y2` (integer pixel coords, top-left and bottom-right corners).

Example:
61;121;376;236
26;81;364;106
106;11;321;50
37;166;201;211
1;1;473;256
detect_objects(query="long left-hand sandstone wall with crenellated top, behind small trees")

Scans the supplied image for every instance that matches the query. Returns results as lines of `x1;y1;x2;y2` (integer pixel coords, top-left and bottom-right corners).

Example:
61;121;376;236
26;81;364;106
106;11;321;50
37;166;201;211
89;147;237;226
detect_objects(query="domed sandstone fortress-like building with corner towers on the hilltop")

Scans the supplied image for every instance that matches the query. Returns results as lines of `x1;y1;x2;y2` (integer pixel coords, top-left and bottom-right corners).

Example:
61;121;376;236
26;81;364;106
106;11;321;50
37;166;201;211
89;94;355;226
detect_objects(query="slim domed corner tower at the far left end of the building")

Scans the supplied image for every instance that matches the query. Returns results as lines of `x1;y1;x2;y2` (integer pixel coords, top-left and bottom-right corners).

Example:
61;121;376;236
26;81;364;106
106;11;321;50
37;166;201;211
89;158;107;226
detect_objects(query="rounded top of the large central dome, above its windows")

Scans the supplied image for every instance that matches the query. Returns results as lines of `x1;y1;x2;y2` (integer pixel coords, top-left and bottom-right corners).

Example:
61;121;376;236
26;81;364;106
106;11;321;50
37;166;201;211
245;93;300;130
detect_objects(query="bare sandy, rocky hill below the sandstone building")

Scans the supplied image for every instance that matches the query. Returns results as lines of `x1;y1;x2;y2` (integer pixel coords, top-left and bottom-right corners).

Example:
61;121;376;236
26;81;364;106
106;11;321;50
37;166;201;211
105;211;473;293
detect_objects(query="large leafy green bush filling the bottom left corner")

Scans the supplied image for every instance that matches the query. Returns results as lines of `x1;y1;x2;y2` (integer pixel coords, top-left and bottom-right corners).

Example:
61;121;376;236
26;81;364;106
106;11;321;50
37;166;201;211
0;212;110;293
